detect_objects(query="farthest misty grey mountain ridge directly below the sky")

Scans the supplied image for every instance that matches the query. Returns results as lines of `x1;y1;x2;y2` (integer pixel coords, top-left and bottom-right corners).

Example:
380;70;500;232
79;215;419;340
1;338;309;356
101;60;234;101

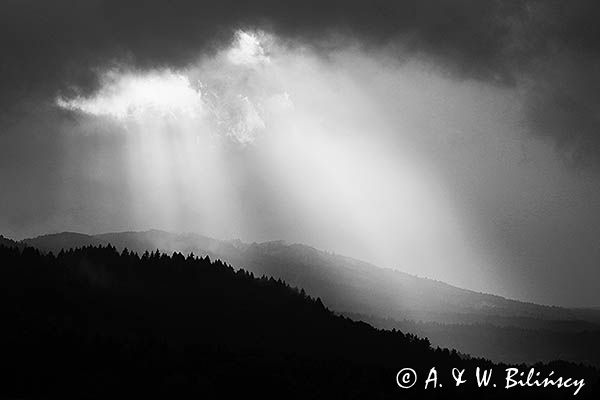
25;230;600;326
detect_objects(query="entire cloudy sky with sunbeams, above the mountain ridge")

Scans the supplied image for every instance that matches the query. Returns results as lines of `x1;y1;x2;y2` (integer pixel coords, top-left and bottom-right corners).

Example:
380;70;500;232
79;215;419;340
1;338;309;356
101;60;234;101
0;0;600;306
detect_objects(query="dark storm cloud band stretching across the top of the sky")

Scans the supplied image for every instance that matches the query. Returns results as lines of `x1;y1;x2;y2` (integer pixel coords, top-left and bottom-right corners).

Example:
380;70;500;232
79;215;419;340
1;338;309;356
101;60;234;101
0;0;600;159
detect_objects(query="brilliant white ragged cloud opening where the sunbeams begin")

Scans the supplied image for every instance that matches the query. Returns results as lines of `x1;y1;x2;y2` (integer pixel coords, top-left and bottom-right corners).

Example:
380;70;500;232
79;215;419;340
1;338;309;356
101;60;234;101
56;31;292;145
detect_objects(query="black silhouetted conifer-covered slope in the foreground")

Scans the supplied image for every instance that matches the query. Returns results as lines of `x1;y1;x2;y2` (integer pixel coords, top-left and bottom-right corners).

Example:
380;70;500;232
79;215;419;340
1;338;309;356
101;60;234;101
0;245;597;398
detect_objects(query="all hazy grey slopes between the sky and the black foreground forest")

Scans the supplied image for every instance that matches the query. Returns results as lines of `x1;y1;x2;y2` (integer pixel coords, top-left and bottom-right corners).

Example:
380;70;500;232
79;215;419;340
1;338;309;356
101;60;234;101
24;230;600;366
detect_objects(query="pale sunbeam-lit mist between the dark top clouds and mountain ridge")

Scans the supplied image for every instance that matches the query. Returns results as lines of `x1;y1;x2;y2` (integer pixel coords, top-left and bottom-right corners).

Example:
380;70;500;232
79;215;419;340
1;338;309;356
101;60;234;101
0;30;600;306
